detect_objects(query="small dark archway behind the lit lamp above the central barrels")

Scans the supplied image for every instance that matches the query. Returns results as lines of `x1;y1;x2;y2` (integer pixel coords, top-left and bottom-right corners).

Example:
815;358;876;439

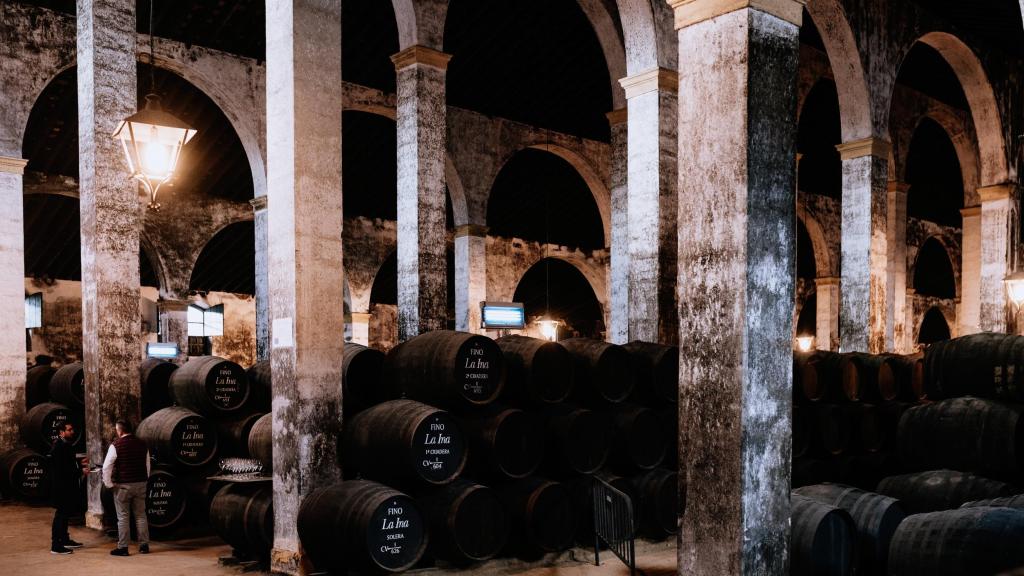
513;257;605;339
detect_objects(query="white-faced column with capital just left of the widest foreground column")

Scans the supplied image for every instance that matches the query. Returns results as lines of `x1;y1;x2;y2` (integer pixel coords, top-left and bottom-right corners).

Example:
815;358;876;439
620;68;679;343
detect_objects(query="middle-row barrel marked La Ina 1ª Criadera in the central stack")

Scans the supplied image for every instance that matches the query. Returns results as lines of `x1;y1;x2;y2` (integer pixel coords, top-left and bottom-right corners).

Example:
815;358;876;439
342;400;466;486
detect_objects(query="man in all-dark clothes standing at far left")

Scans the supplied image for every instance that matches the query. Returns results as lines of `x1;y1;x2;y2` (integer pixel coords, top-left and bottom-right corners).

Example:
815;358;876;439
49;422;89;554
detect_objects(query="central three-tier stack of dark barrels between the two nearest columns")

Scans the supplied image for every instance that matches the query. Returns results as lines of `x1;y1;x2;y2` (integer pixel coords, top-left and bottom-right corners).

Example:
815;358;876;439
284;331;678;572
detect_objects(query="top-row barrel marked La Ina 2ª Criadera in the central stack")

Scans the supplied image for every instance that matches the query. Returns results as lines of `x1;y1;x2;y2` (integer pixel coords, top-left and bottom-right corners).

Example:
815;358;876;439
382;330;505;408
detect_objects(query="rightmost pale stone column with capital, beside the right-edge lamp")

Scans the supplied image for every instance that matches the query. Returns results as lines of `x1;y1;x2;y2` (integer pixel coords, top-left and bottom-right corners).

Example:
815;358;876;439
978;183;1016;332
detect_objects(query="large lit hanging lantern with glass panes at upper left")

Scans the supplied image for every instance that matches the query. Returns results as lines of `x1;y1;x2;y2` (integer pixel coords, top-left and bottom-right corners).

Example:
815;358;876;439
114;94;196;210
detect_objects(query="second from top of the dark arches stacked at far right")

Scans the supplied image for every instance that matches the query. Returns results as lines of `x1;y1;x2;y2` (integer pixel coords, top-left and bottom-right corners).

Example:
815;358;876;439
906;118;964;227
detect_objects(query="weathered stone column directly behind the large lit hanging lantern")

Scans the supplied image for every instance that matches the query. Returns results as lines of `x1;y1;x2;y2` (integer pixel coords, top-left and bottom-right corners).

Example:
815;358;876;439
77;0;141;528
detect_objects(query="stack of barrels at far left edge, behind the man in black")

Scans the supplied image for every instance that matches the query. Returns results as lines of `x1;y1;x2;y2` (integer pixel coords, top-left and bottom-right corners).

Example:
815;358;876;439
0;362;85;501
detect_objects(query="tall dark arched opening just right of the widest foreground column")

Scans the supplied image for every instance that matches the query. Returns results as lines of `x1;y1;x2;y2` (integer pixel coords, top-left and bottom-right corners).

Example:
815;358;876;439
797;79;843;200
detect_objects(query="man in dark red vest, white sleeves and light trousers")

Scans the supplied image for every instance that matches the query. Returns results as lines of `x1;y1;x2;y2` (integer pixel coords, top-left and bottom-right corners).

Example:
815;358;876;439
103;420;150;556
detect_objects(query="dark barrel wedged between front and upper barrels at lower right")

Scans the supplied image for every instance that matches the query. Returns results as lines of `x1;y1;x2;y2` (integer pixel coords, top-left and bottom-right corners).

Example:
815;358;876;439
876;470;1014;513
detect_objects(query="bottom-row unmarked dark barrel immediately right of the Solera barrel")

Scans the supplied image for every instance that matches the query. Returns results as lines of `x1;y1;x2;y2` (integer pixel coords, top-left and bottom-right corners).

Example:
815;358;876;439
416;479;509;565
